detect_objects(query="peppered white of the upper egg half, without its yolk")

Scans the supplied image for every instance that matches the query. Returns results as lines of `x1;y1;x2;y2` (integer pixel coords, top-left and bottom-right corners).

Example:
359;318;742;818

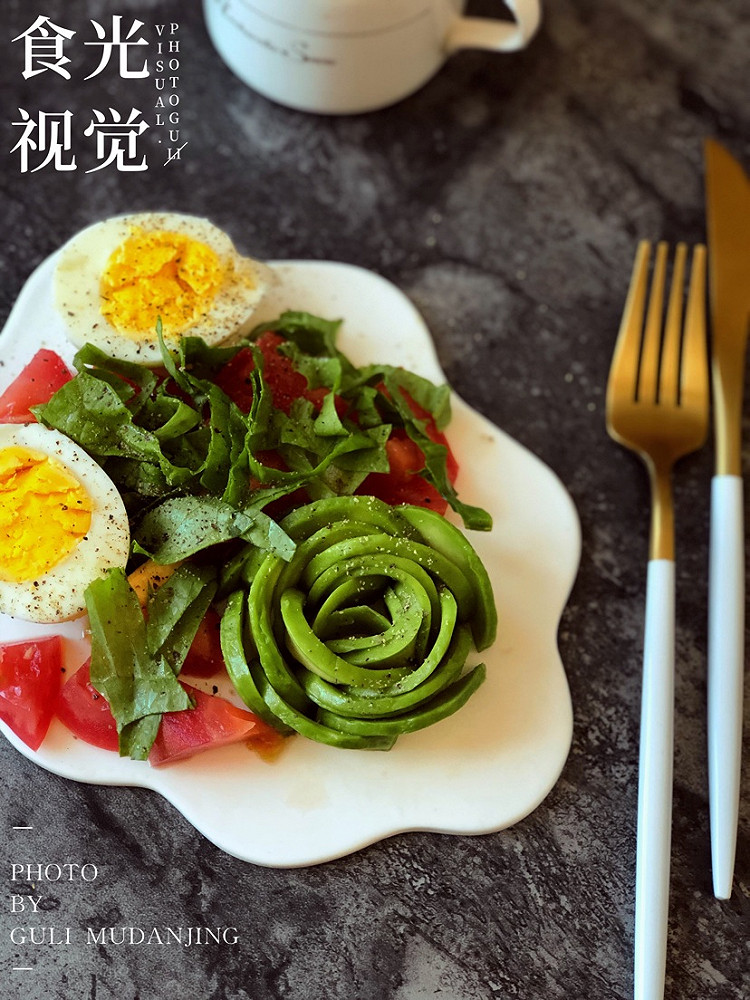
54;212;273;365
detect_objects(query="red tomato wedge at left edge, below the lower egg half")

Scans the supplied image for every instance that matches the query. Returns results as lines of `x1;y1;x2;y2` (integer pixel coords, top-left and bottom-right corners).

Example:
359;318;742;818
0;635;62;750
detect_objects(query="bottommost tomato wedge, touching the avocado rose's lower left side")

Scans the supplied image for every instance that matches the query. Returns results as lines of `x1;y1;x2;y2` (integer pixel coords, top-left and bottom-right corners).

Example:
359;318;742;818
148;684;283;767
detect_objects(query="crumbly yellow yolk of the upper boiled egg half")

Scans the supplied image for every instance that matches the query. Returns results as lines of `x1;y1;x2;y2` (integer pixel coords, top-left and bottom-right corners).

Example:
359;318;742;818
100;229;226;337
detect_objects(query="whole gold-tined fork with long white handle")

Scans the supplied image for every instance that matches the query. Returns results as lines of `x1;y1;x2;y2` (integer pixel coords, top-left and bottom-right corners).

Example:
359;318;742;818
607;241;709;1000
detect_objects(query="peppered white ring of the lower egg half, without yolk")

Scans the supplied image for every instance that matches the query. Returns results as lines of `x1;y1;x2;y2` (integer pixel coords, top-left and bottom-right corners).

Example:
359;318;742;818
0;424;130;624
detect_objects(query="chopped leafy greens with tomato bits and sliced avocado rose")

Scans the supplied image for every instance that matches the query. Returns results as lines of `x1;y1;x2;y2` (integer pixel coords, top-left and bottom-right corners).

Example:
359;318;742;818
33;312;497;759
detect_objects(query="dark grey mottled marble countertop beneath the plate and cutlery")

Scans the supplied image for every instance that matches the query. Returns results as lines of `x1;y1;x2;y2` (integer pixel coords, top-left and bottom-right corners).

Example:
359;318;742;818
0;0;750;1000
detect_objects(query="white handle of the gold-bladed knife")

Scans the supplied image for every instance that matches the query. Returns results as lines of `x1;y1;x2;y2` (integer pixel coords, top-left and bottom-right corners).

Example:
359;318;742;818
708;475;745;899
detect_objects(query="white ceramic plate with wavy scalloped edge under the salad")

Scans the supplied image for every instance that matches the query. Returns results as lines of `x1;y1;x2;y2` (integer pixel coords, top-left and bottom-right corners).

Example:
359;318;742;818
0;257;580;867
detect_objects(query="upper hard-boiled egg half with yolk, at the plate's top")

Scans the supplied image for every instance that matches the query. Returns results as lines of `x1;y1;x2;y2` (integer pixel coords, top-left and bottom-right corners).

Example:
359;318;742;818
54;212;272;364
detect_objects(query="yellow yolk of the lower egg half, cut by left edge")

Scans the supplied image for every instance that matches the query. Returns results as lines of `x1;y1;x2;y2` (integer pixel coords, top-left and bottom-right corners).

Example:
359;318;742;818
0;446;93;583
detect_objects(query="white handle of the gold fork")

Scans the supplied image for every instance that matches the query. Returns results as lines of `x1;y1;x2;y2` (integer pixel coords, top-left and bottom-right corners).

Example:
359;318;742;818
634;559;674;1000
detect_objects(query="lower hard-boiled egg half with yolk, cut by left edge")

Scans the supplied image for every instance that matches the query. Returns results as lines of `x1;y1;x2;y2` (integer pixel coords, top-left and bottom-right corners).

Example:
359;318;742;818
0;424;130;623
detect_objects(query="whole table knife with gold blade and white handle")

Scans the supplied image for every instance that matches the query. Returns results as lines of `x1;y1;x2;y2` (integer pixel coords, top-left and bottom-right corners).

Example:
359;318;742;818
705;140;750;899
